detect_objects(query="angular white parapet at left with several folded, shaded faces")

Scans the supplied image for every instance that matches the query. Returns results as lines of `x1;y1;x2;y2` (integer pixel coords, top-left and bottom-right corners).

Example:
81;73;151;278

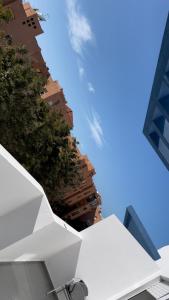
0;146;81;262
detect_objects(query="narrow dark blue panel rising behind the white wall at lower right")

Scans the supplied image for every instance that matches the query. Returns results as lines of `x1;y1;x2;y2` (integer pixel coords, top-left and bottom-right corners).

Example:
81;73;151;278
124;206;160;260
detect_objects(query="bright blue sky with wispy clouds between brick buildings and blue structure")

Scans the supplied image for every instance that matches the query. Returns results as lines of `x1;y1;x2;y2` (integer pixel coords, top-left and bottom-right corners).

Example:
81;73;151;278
30;0;169;247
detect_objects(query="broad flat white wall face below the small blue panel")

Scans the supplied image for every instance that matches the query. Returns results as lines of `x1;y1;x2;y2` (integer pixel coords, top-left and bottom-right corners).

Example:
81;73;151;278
76;216;158;300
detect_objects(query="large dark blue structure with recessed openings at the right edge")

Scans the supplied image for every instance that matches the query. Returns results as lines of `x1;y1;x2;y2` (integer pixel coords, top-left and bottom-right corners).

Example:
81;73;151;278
143;16;169;170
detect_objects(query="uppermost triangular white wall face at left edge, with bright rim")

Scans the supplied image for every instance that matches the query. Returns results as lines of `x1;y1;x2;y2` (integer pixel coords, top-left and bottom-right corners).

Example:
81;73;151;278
0;145;44;216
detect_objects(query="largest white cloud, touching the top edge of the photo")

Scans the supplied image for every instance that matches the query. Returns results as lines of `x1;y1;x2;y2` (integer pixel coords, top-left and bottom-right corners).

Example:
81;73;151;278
66;0;93;56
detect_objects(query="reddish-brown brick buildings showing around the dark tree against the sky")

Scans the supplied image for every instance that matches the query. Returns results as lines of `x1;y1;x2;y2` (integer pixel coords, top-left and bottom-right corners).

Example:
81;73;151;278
3;0;101;228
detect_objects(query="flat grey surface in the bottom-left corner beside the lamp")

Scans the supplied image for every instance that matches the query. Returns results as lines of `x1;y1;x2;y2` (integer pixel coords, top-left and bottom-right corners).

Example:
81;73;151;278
0;262;56;300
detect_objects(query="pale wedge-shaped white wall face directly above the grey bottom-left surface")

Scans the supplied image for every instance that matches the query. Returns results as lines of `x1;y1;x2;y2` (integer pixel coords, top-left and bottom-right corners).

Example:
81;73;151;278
0;222;81;262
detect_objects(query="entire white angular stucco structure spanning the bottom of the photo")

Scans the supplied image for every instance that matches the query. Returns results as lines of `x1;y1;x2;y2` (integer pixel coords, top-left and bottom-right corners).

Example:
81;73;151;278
0;147;166;300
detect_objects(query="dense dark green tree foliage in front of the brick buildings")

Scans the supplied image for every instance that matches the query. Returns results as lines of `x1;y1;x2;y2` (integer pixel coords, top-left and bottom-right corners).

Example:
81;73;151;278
0;37;79;209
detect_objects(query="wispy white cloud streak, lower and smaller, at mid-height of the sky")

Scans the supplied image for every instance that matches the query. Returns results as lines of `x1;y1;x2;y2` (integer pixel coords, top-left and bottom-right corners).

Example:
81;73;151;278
87;112;104;148
